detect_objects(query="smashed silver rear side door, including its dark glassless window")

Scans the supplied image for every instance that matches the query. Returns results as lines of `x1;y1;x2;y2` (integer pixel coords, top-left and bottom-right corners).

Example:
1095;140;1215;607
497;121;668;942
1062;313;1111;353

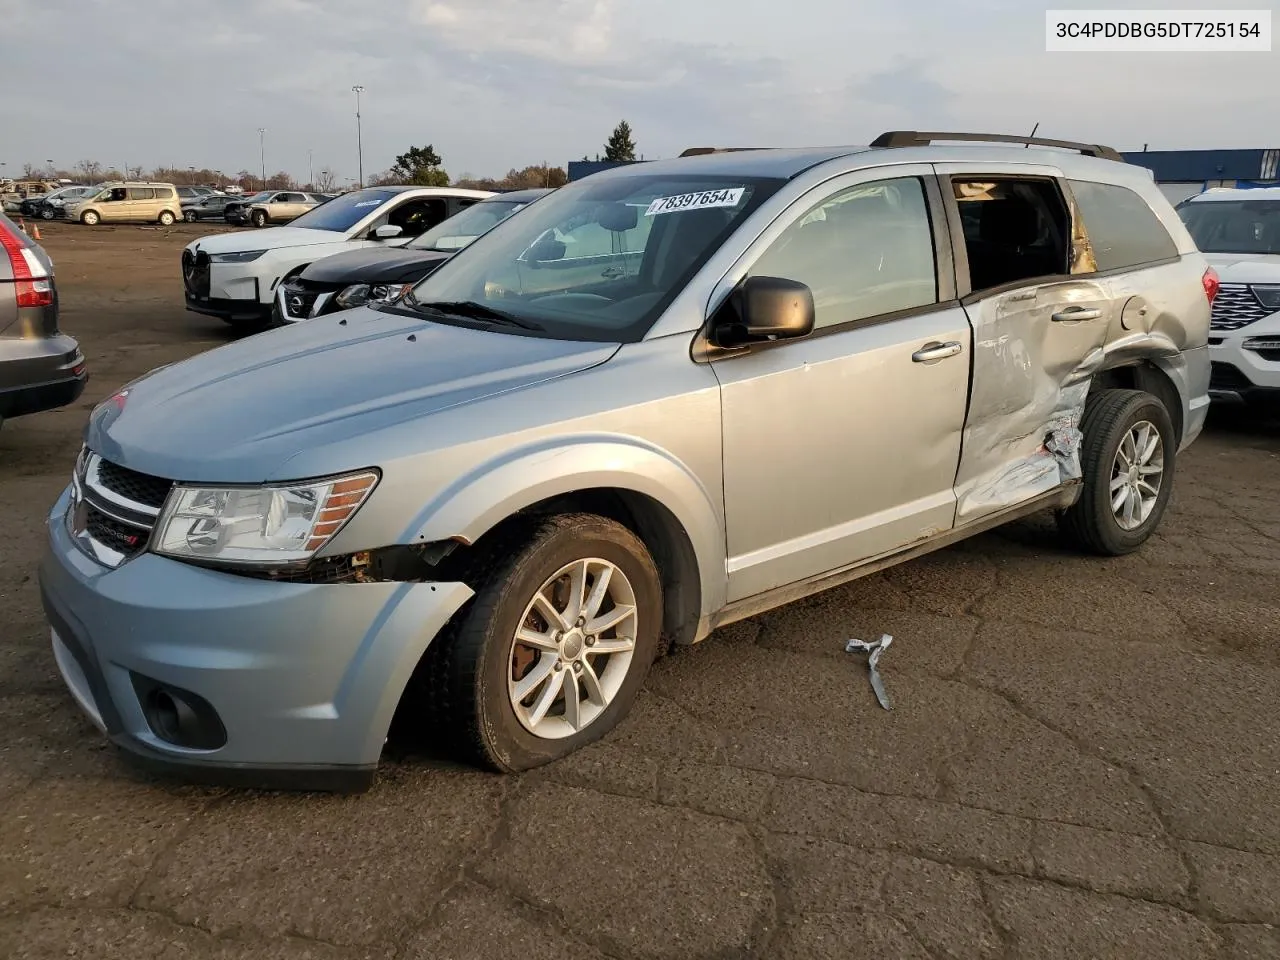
936;164;1117;525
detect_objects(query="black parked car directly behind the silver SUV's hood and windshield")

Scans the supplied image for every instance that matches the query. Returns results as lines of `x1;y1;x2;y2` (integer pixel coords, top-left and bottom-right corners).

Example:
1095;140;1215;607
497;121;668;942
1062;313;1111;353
271;189;550;325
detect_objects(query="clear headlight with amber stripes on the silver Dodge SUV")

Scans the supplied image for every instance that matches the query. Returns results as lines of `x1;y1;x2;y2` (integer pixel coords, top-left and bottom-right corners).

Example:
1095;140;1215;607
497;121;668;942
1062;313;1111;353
151;471;378;566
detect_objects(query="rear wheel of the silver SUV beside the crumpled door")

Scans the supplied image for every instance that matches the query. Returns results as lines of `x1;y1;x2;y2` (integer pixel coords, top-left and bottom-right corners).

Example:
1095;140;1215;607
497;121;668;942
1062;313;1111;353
1057;390;1178;557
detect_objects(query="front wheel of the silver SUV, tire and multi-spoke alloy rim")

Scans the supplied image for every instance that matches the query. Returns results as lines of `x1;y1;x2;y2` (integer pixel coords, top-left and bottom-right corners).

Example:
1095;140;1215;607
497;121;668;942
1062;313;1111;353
421;515;663;772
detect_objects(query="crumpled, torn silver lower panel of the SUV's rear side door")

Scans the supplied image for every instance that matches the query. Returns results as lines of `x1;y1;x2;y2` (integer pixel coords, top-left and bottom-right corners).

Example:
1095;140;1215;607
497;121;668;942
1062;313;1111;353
956;284;1111;525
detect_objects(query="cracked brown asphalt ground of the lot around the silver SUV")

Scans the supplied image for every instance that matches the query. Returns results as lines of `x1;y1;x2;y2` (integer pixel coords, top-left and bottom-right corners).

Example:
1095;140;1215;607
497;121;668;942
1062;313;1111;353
0;224;1280;960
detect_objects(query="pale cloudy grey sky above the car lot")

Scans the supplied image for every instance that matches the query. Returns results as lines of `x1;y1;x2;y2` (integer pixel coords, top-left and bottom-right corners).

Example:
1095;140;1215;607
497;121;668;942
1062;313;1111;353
0;0;1280;183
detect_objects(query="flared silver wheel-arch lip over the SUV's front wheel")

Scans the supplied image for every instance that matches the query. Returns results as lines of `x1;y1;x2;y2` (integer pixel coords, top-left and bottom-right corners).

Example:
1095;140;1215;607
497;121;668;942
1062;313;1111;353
402;435;726;616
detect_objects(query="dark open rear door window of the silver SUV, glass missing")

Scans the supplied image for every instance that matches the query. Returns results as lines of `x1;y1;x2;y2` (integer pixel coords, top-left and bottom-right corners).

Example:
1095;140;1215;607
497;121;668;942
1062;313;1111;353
952;178;1071;292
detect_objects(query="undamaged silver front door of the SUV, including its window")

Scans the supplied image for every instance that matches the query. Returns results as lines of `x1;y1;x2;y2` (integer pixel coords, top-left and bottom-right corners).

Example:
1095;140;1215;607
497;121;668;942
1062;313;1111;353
716;165;972;602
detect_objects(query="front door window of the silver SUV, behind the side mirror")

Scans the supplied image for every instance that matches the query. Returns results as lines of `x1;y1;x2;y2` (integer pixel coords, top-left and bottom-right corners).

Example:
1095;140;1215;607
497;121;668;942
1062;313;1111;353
750;178;938;328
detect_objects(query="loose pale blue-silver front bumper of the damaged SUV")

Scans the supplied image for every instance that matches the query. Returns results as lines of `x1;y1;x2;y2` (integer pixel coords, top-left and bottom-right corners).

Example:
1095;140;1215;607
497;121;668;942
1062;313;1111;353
40;492;481;791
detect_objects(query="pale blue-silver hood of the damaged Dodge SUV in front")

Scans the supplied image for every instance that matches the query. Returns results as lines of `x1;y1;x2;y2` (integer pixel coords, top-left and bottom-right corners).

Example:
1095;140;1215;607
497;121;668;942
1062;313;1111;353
86;307;618;483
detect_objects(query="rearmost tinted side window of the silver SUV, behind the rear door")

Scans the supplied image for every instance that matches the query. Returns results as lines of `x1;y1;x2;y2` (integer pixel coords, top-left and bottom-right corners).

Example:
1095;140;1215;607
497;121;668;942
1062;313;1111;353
1068;180;1178;270
